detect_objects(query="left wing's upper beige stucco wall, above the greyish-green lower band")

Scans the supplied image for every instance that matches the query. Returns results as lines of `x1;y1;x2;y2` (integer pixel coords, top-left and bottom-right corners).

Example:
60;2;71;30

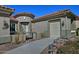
0;17;10;36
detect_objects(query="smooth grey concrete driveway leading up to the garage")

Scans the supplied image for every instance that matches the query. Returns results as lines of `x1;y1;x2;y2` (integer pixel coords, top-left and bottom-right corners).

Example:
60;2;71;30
6;38;54;54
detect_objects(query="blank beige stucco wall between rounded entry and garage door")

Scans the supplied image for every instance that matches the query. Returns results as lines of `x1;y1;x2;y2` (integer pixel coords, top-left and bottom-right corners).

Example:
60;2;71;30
32;21;48;33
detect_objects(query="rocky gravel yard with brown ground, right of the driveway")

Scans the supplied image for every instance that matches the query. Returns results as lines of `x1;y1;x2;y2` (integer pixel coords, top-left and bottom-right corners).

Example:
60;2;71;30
41;37;79;54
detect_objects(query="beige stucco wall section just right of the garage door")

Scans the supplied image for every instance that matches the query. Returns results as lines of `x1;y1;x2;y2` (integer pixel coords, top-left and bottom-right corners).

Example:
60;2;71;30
60;17;71;38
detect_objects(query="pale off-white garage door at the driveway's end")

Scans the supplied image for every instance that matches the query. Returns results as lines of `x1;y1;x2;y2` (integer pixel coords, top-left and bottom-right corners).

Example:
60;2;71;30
50;21;60;39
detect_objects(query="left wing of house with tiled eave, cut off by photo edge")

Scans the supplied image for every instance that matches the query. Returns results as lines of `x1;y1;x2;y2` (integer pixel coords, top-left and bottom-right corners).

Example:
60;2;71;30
0;6;14;44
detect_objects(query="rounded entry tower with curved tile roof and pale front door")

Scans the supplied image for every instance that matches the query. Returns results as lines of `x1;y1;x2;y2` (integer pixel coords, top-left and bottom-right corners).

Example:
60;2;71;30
14;12;35;39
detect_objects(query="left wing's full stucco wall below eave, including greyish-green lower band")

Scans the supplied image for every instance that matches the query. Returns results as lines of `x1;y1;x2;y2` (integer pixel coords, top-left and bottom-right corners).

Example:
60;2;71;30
0;17;11;44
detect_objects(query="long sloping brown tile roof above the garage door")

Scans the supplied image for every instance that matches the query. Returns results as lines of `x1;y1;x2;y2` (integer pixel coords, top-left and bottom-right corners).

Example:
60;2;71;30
32;9;74;23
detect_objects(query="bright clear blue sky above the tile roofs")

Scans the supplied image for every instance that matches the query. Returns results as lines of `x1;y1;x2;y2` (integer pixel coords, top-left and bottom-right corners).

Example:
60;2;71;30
6;5;79;17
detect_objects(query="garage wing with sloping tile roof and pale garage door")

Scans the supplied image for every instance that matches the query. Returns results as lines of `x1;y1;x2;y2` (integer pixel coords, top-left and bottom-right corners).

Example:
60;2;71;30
32;10;76;39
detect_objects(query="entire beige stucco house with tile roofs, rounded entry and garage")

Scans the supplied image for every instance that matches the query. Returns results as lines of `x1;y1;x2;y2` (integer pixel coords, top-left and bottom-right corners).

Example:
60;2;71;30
0;6;79;44
